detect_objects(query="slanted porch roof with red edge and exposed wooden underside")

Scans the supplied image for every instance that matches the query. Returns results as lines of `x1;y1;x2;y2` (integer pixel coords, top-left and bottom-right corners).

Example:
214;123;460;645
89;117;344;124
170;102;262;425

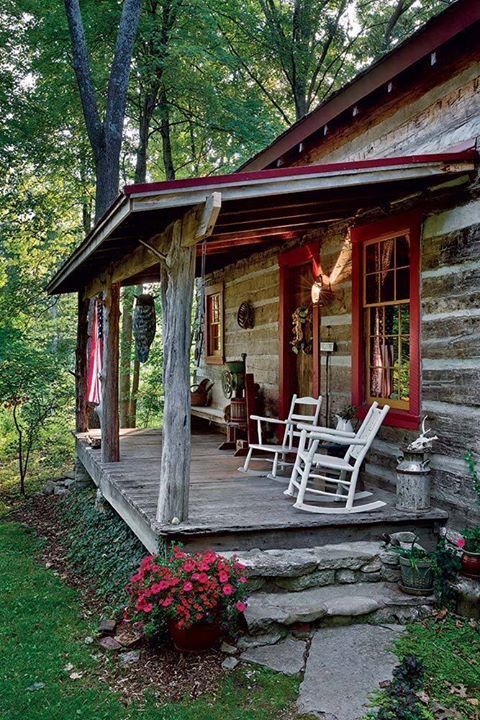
47;147;477;294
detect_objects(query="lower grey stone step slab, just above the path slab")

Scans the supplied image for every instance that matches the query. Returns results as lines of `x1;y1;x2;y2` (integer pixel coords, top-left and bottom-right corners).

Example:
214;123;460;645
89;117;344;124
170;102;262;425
245;582;433;633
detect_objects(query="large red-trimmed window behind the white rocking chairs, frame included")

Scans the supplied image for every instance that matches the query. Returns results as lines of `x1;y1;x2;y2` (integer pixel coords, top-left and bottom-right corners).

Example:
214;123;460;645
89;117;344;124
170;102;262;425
352;215;420;428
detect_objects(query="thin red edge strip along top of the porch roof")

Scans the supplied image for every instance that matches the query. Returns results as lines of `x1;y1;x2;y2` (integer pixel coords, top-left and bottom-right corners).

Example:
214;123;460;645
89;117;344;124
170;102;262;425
123;148;480;196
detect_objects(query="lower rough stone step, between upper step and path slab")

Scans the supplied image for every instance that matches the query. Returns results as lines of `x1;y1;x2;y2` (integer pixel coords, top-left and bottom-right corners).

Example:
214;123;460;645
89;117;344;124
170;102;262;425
245;582;434;635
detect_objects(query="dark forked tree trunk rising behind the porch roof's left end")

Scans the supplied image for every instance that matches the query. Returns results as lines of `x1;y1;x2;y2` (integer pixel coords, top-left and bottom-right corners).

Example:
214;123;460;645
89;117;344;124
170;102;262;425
65;0;142;220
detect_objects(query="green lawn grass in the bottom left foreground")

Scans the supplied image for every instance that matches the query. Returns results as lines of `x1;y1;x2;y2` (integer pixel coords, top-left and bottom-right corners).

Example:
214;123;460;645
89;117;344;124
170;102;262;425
0;523;297;720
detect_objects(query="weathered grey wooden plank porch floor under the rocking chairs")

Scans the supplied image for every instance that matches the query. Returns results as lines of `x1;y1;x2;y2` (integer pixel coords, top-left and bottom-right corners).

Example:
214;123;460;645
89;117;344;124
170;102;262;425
77;429;447;552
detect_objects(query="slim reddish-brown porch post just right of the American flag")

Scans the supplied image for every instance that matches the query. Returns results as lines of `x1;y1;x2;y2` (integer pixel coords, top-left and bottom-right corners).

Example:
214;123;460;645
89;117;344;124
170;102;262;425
101;276;120;462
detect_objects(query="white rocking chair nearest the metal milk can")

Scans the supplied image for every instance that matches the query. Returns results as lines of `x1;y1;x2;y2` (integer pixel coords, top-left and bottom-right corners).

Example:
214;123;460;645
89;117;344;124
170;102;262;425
285;403;390;514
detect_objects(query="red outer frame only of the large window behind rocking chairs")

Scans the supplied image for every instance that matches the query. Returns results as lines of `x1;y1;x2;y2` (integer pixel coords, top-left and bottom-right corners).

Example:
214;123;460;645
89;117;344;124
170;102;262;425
351;212;422;430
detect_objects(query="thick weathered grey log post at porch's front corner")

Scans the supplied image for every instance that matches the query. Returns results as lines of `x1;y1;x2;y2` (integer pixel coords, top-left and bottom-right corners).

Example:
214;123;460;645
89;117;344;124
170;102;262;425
157;221;195;523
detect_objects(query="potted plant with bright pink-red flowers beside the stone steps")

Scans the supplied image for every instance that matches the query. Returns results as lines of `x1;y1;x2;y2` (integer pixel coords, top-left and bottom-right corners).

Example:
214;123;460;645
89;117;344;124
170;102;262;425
126;547;247;652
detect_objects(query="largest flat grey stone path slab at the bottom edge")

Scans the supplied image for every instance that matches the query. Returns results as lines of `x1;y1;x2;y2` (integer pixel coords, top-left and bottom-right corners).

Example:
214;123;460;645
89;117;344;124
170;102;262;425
297;625;403;720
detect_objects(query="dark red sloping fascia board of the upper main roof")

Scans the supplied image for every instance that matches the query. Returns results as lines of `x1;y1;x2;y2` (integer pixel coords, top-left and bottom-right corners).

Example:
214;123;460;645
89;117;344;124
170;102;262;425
240;0;480;171
